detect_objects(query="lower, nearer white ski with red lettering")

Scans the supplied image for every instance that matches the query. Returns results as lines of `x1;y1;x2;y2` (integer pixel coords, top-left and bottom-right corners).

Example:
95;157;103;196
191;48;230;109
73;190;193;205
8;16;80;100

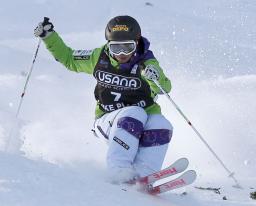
146;170;196;195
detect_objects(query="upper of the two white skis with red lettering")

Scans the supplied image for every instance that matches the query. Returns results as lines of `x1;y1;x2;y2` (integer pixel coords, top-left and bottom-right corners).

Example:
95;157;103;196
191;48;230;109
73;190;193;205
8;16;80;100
136;158;189;185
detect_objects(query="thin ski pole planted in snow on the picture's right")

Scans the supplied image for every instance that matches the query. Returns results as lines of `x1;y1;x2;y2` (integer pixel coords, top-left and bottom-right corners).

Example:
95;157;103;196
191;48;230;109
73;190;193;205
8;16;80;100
153;80;242;188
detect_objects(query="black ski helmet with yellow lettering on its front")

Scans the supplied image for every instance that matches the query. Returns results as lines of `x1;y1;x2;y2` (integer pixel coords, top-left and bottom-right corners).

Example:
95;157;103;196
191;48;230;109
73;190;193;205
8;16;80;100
105;16;141;41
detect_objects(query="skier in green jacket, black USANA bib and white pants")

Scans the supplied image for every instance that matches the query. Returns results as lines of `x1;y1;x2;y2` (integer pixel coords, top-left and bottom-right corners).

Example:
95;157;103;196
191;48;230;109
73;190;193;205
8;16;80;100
34;16;172;183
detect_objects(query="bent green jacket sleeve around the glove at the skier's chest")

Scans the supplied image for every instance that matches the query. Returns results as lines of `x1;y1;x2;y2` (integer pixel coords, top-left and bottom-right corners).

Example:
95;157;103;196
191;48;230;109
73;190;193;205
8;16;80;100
144;59;172;94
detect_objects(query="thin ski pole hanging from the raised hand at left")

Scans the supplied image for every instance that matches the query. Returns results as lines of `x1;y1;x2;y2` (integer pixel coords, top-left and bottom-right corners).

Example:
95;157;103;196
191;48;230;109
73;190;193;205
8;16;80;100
5;39;41;151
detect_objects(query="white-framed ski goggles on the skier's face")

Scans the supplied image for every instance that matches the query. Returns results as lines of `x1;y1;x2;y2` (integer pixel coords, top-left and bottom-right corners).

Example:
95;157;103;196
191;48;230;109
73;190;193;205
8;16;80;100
108;40;136;55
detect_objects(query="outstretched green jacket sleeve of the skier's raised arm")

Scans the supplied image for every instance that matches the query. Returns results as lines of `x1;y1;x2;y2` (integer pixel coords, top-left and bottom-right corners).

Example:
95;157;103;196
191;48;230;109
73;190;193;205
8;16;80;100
44;32;103;74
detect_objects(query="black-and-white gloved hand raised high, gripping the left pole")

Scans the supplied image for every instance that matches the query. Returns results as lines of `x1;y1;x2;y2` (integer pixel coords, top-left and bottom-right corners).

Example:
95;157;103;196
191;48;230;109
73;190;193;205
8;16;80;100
34;17;54;39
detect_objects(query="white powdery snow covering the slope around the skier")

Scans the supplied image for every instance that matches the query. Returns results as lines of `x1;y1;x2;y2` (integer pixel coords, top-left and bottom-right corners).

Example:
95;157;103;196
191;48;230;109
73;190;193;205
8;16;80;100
0;0;256;206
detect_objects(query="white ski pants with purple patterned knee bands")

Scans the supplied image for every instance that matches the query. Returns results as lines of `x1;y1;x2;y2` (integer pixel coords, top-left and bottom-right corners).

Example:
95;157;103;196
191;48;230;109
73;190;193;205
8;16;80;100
94;106;173;178
